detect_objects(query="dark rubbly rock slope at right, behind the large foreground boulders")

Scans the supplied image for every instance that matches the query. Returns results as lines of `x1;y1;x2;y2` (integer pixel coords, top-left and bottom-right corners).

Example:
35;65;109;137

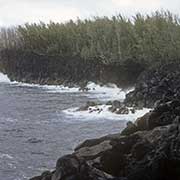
125;63;180;108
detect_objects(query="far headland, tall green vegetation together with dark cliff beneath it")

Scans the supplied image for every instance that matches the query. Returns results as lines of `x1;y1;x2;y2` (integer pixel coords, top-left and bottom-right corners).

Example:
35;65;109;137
0;11;180;85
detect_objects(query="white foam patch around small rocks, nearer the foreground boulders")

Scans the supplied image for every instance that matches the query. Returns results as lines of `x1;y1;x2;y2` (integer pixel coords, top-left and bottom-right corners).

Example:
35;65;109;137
63;105;150;121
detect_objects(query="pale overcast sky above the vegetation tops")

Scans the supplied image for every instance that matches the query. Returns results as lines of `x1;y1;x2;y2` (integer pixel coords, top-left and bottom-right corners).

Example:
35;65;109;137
0;0;180;26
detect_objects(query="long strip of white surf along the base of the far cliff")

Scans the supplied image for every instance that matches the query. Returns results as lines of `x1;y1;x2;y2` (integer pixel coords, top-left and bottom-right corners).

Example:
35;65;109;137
0;73;133;101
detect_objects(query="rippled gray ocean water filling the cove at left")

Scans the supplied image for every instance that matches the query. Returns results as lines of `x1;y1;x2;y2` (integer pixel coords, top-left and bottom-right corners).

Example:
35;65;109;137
0;76;126;180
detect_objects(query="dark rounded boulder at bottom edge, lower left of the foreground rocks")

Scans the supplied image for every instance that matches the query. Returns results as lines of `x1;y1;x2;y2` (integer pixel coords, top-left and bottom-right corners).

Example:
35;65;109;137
51;155;114;180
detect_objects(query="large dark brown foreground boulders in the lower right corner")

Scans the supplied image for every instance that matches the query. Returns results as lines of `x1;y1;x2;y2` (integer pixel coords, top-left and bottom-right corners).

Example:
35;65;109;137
31;97;180;180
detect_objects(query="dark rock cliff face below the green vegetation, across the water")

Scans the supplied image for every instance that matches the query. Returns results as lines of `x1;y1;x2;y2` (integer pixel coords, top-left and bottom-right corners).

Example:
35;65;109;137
0;50;143;86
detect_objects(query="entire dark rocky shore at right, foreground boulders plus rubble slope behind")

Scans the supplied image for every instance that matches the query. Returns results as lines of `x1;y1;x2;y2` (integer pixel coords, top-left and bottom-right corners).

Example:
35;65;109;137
31;64;180;180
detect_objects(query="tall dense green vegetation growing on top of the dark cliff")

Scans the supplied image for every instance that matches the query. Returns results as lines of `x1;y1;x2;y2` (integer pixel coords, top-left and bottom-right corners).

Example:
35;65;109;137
0;11;180;84
